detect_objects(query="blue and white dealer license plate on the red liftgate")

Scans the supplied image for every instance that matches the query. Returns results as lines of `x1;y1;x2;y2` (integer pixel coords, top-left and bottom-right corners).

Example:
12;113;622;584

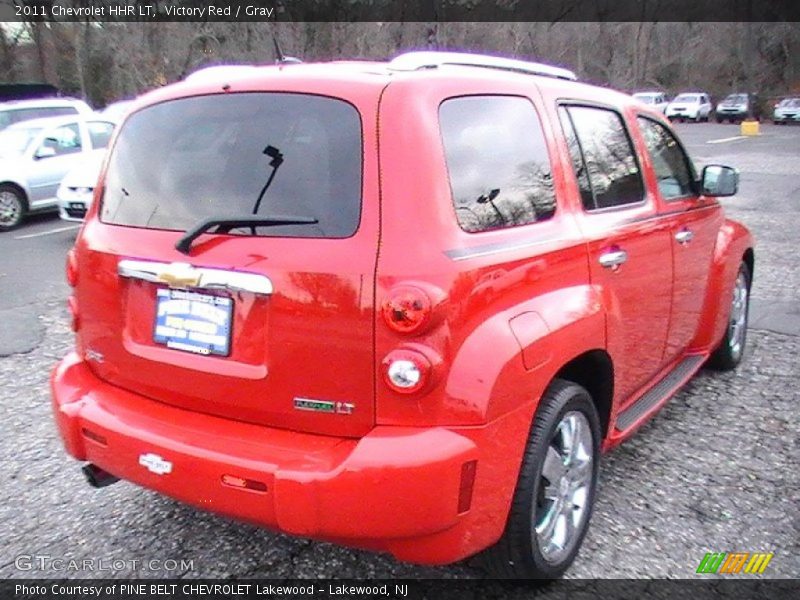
153;288;233;356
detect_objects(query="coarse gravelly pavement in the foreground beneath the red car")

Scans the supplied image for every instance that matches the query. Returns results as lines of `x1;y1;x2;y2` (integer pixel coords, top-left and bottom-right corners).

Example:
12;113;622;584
0;306;800;578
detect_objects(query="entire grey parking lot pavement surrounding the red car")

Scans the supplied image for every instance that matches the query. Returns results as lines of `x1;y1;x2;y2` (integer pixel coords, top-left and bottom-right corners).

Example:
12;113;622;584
0;124;800;580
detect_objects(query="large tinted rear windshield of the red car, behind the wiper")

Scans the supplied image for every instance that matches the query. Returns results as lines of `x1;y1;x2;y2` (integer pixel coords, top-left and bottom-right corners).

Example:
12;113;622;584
100;93;362;238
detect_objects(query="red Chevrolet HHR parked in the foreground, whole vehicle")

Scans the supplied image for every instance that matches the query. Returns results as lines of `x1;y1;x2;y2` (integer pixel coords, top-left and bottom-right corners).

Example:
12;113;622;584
51;52;754;577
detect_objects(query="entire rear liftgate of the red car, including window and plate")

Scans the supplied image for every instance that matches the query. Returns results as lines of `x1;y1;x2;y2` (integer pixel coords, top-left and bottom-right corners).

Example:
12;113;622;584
76;92;378;436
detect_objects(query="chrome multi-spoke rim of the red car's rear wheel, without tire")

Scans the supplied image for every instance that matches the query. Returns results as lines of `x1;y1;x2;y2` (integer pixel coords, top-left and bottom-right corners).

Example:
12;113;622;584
532;411;594;563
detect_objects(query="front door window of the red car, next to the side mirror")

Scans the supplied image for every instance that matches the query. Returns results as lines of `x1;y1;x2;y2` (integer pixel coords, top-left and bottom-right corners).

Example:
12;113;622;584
639;118;695;200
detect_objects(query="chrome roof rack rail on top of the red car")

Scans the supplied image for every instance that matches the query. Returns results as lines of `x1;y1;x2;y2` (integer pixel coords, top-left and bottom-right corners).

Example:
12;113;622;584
389;51;578;81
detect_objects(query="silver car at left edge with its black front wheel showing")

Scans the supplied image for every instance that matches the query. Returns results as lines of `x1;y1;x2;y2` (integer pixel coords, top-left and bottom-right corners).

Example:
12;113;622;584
0;116;114;231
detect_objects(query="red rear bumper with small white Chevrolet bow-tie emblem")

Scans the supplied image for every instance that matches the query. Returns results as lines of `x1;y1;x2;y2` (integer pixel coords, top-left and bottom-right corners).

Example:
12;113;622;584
51;353;500;563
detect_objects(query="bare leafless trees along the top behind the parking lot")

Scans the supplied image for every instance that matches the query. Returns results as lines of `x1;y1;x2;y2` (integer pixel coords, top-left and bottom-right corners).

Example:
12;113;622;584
0;21;800;107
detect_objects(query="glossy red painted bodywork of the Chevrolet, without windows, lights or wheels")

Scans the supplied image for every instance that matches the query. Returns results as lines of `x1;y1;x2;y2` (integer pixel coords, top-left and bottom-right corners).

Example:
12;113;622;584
51;58;752;563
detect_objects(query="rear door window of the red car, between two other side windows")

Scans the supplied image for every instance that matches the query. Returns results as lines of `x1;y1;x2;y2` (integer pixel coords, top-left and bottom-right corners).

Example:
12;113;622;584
567;106;644;210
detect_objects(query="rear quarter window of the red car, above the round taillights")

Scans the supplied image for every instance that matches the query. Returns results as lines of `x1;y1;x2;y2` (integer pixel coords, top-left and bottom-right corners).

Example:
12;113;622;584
439;96;555;232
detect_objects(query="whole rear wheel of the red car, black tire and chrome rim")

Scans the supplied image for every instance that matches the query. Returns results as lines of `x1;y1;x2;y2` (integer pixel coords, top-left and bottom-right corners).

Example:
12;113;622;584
482;379;601;579
